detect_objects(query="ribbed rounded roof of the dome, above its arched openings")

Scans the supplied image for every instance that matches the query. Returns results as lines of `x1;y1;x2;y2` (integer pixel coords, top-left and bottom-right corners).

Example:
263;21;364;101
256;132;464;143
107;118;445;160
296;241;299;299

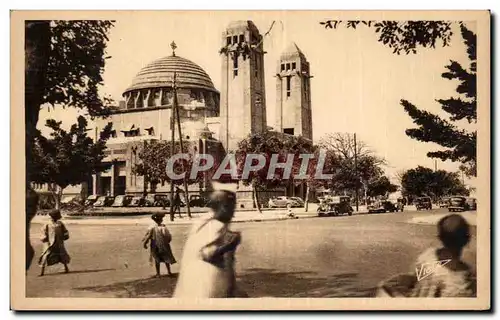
124;56;218;94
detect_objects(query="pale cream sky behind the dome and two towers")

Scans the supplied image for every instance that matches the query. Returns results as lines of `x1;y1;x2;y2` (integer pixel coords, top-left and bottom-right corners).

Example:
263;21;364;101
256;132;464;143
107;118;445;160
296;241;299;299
39;11;474;185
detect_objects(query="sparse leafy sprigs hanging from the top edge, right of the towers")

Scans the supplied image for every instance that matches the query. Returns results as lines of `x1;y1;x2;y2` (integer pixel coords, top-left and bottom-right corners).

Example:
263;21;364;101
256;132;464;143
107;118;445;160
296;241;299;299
320;20;453;55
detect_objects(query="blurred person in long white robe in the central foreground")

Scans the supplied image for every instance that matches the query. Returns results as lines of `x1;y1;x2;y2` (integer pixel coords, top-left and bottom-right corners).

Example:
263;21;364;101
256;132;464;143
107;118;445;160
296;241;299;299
173;182;241;299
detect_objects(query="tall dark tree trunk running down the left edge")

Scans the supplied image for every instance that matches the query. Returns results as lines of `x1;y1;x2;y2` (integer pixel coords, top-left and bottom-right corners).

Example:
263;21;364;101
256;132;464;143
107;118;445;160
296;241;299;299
24;21;50;270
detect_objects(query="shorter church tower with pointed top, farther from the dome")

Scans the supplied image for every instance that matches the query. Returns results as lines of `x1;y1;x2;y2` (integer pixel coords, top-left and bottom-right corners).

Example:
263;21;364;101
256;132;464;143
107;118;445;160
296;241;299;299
275;43;312;140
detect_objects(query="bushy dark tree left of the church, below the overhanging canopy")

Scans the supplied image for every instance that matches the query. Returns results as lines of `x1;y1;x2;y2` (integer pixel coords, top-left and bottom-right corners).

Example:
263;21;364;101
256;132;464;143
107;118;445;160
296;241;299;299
31;116;112;209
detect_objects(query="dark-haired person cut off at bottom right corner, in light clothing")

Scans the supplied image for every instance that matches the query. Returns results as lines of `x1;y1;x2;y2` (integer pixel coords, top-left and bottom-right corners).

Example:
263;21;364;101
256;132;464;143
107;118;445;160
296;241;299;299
379;214;476;298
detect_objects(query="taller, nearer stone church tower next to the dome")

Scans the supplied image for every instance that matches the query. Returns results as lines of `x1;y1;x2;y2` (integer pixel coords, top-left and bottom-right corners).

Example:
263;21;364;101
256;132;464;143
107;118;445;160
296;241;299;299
220;21;267;151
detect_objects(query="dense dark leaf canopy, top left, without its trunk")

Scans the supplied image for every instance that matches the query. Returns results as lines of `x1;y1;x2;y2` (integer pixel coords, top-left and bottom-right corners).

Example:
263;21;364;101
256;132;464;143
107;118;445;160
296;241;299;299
28;20;113;116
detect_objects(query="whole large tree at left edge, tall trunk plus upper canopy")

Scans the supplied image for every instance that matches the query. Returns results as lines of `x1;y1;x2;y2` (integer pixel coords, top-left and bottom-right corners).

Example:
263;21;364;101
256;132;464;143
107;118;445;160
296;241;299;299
24;20;113;269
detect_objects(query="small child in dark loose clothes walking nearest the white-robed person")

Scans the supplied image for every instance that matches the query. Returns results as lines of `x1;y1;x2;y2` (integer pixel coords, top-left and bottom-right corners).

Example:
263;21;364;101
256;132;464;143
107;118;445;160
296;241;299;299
142;213;177;277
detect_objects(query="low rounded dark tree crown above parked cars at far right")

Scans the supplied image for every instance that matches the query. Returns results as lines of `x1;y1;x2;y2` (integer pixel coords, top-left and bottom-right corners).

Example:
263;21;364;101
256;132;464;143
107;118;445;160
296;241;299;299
402;166;468;199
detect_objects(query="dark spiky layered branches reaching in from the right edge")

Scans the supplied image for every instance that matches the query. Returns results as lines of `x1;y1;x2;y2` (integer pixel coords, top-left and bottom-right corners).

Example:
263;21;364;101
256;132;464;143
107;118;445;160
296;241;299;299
401;24;477;177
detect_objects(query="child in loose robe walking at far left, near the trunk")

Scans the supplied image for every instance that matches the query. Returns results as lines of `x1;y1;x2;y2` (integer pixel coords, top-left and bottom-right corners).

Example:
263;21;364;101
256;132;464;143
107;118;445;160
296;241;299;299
38;209;70;276
